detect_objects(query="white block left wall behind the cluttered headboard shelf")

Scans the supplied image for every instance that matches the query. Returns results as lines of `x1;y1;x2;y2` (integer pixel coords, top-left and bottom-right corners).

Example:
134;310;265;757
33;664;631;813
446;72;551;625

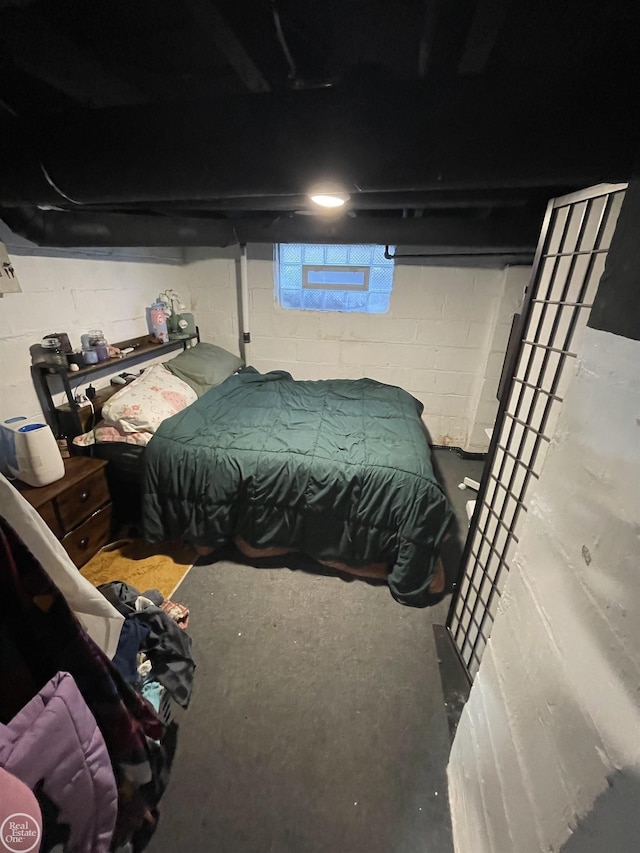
0;244;189;420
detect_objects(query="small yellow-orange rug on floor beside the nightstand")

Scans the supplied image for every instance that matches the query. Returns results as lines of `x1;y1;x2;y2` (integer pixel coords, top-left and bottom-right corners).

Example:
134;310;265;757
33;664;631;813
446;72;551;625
80;539;198;598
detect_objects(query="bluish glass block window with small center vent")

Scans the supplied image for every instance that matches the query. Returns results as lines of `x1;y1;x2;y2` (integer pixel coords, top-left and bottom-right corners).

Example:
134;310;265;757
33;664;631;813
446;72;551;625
274;243;394;314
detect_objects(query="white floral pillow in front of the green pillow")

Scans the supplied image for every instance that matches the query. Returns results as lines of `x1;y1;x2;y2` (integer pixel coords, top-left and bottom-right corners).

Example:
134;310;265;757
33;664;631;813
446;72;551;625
102;364;198;433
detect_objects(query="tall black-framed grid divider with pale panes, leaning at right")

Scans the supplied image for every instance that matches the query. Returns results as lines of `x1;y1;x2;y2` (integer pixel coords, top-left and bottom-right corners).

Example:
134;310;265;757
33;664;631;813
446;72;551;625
447;184;626;679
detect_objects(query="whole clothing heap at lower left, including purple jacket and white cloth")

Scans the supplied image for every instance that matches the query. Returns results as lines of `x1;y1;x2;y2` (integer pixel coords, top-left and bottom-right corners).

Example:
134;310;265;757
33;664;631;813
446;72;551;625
0;475;194;853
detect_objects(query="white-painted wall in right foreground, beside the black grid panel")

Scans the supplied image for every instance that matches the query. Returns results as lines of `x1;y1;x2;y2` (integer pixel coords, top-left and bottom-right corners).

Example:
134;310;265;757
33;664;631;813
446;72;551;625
448;329;640;853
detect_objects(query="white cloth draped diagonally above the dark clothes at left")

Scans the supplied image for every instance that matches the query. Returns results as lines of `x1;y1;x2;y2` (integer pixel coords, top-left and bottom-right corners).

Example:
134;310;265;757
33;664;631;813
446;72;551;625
0;474;124;658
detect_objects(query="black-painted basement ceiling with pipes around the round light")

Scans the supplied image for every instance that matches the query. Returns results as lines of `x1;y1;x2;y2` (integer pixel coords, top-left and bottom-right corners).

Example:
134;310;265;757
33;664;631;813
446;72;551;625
0;0;640;255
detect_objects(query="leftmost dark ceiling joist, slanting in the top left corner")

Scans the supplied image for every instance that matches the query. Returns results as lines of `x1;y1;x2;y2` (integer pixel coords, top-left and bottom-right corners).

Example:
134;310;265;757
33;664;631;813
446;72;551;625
0;10;149;107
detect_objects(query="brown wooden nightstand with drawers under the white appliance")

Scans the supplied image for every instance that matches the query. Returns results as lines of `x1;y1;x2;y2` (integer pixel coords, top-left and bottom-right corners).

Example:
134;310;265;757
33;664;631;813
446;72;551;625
15;456;111;568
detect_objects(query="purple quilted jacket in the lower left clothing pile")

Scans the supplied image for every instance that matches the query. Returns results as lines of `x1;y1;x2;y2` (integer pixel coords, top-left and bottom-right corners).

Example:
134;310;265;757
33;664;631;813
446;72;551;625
0;672;117;853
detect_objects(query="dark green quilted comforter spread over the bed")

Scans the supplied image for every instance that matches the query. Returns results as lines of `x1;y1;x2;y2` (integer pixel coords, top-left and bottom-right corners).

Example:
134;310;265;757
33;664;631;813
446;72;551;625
143;371;452;607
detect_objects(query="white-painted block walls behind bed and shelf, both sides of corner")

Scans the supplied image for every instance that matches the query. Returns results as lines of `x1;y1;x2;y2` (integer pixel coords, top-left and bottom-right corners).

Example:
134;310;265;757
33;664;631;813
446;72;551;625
0;236;528;450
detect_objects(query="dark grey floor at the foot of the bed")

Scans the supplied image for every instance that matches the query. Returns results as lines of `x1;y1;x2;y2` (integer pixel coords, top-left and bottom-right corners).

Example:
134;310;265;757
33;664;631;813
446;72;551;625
148;451;481;853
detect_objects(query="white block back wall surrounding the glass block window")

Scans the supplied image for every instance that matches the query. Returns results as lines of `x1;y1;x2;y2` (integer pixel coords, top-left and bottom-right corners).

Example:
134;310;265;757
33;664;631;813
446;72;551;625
187;253;523;450
